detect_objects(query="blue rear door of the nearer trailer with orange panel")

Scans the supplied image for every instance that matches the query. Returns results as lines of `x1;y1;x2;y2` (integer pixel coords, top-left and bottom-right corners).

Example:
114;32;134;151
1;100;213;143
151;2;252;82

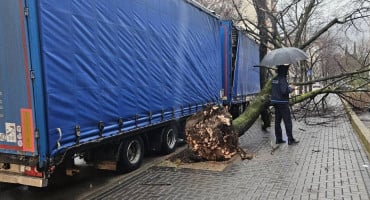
0;0;36;155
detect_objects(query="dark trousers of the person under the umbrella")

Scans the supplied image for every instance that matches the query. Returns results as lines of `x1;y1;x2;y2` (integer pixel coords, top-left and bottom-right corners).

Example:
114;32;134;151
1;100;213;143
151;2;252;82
274;104;293;140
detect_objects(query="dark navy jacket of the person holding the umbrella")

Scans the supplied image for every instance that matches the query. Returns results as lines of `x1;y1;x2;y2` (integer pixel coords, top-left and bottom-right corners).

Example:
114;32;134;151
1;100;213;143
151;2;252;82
271;75;293;104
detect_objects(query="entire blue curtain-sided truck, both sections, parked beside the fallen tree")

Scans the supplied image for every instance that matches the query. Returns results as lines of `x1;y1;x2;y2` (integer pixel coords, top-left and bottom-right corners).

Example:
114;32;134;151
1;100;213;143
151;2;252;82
0;0;259;187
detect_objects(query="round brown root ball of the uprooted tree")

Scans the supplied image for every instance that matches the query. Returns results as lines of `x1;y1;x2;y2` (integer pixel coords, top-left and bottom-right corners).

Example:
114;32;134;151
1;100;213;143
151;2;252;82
185;105;240;161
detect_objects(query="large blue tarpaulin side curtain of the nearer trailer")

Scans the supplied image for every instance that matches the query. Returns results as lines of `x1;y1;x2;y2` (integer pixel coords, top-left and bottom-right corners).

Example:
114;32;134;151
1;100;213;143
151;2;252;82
39;0;222;155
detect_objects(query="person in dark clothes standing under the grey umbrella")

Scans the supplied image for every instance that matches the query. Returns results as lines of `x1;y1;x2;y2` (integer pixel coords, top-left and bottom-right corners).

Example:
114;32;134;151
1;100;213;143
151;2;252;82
271;65;299;145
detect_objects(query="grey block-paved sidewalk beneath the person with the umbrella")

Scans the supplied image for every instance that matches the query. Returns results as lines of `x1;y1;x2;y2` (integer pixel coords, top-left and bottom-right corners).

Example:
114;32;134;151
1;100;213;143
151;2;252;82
89;96;370;200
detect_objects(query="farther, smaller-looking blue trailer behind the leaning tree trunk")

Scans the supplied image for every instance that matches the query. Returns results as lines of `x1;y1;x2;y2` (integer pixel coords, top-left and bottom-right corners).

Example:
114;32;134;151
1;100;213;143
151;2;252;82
220;20;261;118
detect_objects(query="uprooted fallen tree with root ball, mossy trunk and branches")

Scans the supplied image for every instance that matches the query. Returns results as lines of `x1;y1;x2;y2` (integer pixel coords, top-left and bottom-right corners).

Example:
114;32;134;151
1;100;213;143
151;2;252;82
185;69;370;161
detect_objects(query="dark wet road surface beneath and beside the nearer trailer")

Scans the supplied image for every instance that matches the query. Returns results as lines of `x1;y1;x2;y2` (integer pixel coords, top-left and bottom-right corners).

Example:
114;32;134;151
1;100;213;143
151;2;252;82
0;147;171;200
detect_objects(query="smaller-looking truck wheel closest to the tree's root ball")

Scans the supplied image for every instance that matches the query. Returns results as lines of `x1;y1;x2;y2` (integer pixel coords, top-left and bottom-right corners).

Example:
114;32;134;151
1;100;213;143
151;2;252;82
161;125;178;154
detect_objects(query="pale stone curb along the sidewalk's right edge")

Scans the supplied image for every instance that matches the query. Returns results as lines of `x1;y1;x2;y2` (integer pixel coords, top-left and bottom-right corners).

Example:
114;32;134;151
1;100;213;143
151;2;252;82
342;101;370;156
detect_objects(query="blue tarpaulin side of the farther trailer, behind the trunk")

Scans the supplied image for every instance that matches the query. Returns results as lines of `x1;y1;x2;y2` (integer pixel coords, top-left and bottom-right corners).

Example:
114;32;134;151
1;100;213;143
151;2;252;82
232;31;261;100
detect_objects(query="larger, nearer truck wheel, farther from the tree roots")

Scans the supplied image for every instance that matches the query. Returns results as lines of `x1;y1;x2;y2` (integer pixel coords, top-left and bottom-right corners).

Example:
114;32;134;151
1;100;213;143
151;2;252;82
117;137;144;172
